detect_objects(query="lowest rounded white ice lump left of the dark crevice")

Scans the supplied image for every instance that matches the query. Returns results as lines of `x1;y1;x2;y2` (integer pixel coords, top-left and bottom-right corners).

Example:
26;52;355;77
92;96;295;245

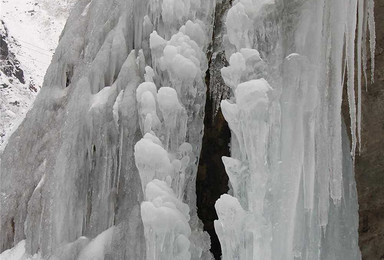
141;179;191;260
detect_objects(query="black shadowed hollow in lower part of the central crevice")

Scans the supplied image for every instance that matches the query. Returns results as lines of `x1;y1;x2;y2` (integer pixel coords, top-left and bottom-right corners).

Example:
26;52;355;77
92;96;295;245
196;72;231;259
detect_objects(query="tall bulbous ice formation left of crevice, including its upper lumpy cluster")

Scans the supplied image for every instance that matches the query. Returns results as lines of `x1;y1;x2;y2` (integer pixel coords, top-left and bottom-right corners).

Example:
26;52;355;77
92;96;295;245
135;6;214;259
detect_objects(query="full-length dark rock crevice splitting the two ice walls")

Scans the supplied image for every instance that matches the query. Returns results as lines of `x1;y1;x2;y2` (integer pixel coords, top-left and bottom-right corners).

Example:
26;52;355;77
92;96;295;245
196;0;232;259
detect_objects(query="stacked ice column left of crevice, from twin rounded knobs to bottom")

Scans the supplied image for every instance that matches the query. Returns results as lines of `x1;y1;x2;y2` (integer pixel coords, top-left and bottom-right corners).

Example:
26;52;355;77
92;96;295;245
135;77;192;260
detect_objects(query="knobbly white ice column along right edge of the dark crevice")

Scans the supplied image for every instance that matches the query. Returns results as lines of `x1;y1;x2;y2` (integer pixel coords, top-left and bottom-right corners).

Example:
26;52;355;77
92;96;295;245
215;48;272;259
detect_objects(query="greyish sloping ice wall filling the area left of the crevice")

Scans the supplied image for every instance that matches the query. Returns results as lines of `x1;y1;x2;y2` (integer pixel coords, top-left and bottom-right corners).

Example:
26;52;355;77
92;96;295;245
0;0;215;259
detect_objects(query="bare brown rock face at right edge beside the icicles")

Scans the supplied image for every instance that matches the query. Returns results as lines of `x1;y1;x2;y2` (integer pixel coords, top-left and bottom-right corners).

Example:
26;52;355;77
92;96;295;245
355;0;384;260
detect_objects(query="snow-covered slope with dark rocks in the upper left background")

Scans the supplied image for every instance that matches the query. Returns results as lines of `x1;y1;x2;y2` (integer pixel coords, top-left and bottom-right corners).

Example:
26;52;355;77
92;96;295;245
0;0;75;150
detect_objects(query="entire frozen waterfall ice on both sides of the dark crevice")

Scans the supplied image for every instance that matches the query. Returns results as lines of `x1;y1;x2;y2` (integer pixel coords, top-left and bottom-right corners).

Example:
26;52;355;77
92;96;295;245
0;0;374;260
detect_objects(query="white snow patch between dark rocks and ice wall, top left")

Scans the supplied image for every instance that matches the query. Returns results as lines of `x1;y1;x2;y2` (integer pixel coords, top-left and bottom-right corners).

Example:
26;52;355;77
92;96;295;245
1;0;77;86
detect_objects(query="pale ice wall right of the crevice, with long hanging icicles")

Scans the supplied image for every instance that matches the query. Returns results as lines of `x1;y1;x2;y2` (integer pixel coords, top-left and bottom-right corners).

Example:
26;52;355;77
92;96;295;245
215;0;374;259
